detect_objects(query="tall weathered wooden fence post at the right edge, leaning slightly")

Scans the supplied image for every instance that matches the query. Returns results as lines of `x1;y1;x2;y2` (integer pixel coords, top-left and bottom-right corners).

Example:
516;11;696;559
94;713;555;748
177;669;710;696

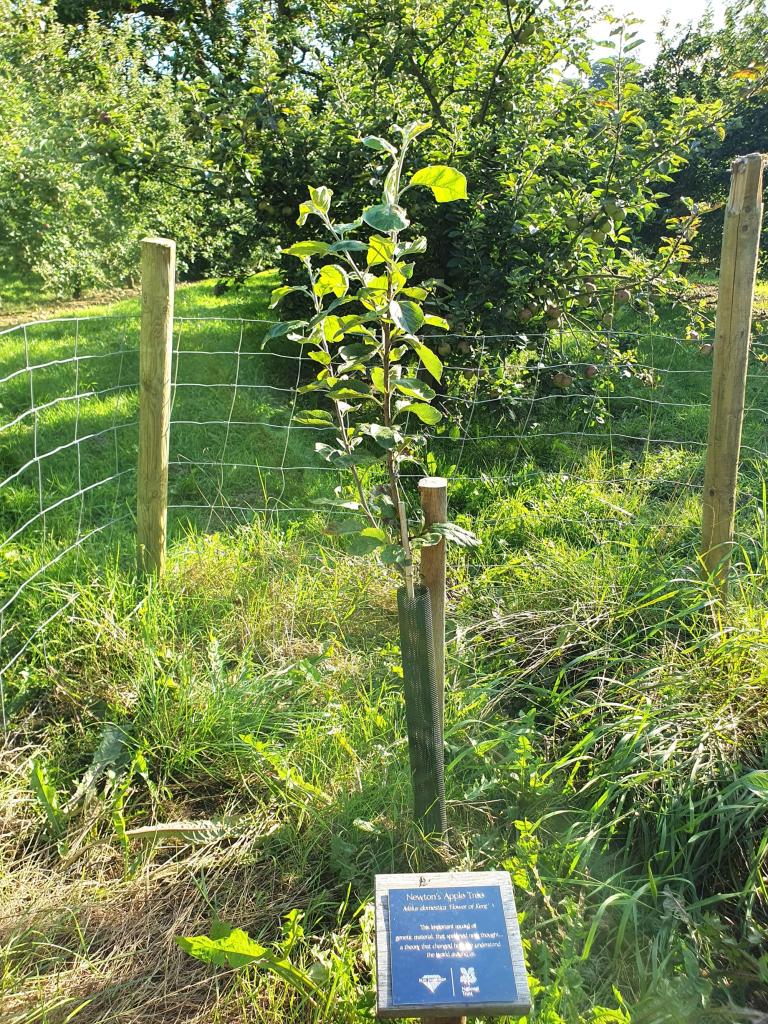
701;153;763;597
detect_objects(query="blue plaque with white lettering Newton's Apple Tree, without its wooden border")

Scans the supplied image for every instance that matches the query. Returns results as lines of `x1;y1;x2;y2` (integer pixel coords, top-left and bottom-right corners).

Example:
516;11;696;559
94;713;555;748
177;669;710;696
389;886;517;1006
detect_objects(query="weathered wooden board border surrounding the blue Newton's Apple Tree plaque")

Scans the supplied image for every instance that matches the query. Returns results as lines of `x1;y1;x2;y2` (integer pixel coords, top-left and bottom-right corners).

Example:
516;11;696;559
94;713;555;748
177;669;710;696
375;871;530;1020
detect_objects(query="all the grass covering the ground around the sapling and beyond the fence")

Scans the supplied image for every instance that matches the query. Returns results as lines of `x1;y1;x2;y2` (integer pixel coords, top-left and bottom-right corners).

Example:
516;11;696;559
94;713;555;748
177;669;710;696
0;274;768;1024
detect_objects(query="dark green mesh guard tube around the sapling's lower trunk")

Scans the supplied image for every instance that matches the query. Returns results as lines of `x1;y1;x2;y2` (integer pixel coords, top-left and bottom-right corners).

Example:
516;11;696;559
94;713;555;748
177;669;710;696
397;587;445;835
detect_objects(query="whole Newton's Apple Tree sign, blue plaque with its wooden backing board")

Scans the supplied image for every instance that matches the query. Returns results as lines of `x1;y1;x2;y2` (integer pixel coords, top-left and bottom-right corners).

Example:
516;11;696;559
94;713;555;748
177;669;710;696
375;871;530;1024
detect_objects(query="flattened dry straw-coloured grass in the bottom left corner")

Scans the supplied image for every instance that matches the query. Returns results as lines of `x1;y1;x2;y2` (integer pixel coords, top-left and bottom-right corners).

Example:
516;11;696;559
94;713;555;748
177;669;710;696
0;811;321;1024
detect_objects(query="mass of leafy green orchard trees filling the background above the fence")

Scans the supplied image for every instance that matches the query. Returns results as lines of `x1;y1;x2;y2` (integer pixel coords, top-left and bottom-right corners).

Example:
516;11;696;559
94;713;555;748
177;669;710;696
0;0;765;330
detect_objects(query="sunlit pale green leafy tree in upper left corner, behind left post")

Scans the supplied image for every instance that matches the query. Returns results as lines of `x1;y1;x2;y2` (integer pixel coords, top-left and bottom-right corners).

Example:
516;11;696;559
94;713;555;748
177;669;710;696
0;0;209;296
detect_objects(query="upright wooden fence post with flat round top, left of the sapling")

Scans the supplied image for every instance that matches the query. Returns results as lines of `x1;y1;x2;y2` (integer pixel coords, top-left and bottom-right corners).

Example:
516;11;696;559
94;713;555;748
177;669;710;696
136;239;176;575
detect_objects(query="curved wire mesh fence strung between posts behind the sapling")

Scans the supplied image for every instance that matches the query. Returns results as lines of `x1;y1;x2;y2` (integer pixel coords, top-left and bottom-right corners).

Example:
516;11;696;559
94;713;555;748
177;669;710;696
0;315;768;729
